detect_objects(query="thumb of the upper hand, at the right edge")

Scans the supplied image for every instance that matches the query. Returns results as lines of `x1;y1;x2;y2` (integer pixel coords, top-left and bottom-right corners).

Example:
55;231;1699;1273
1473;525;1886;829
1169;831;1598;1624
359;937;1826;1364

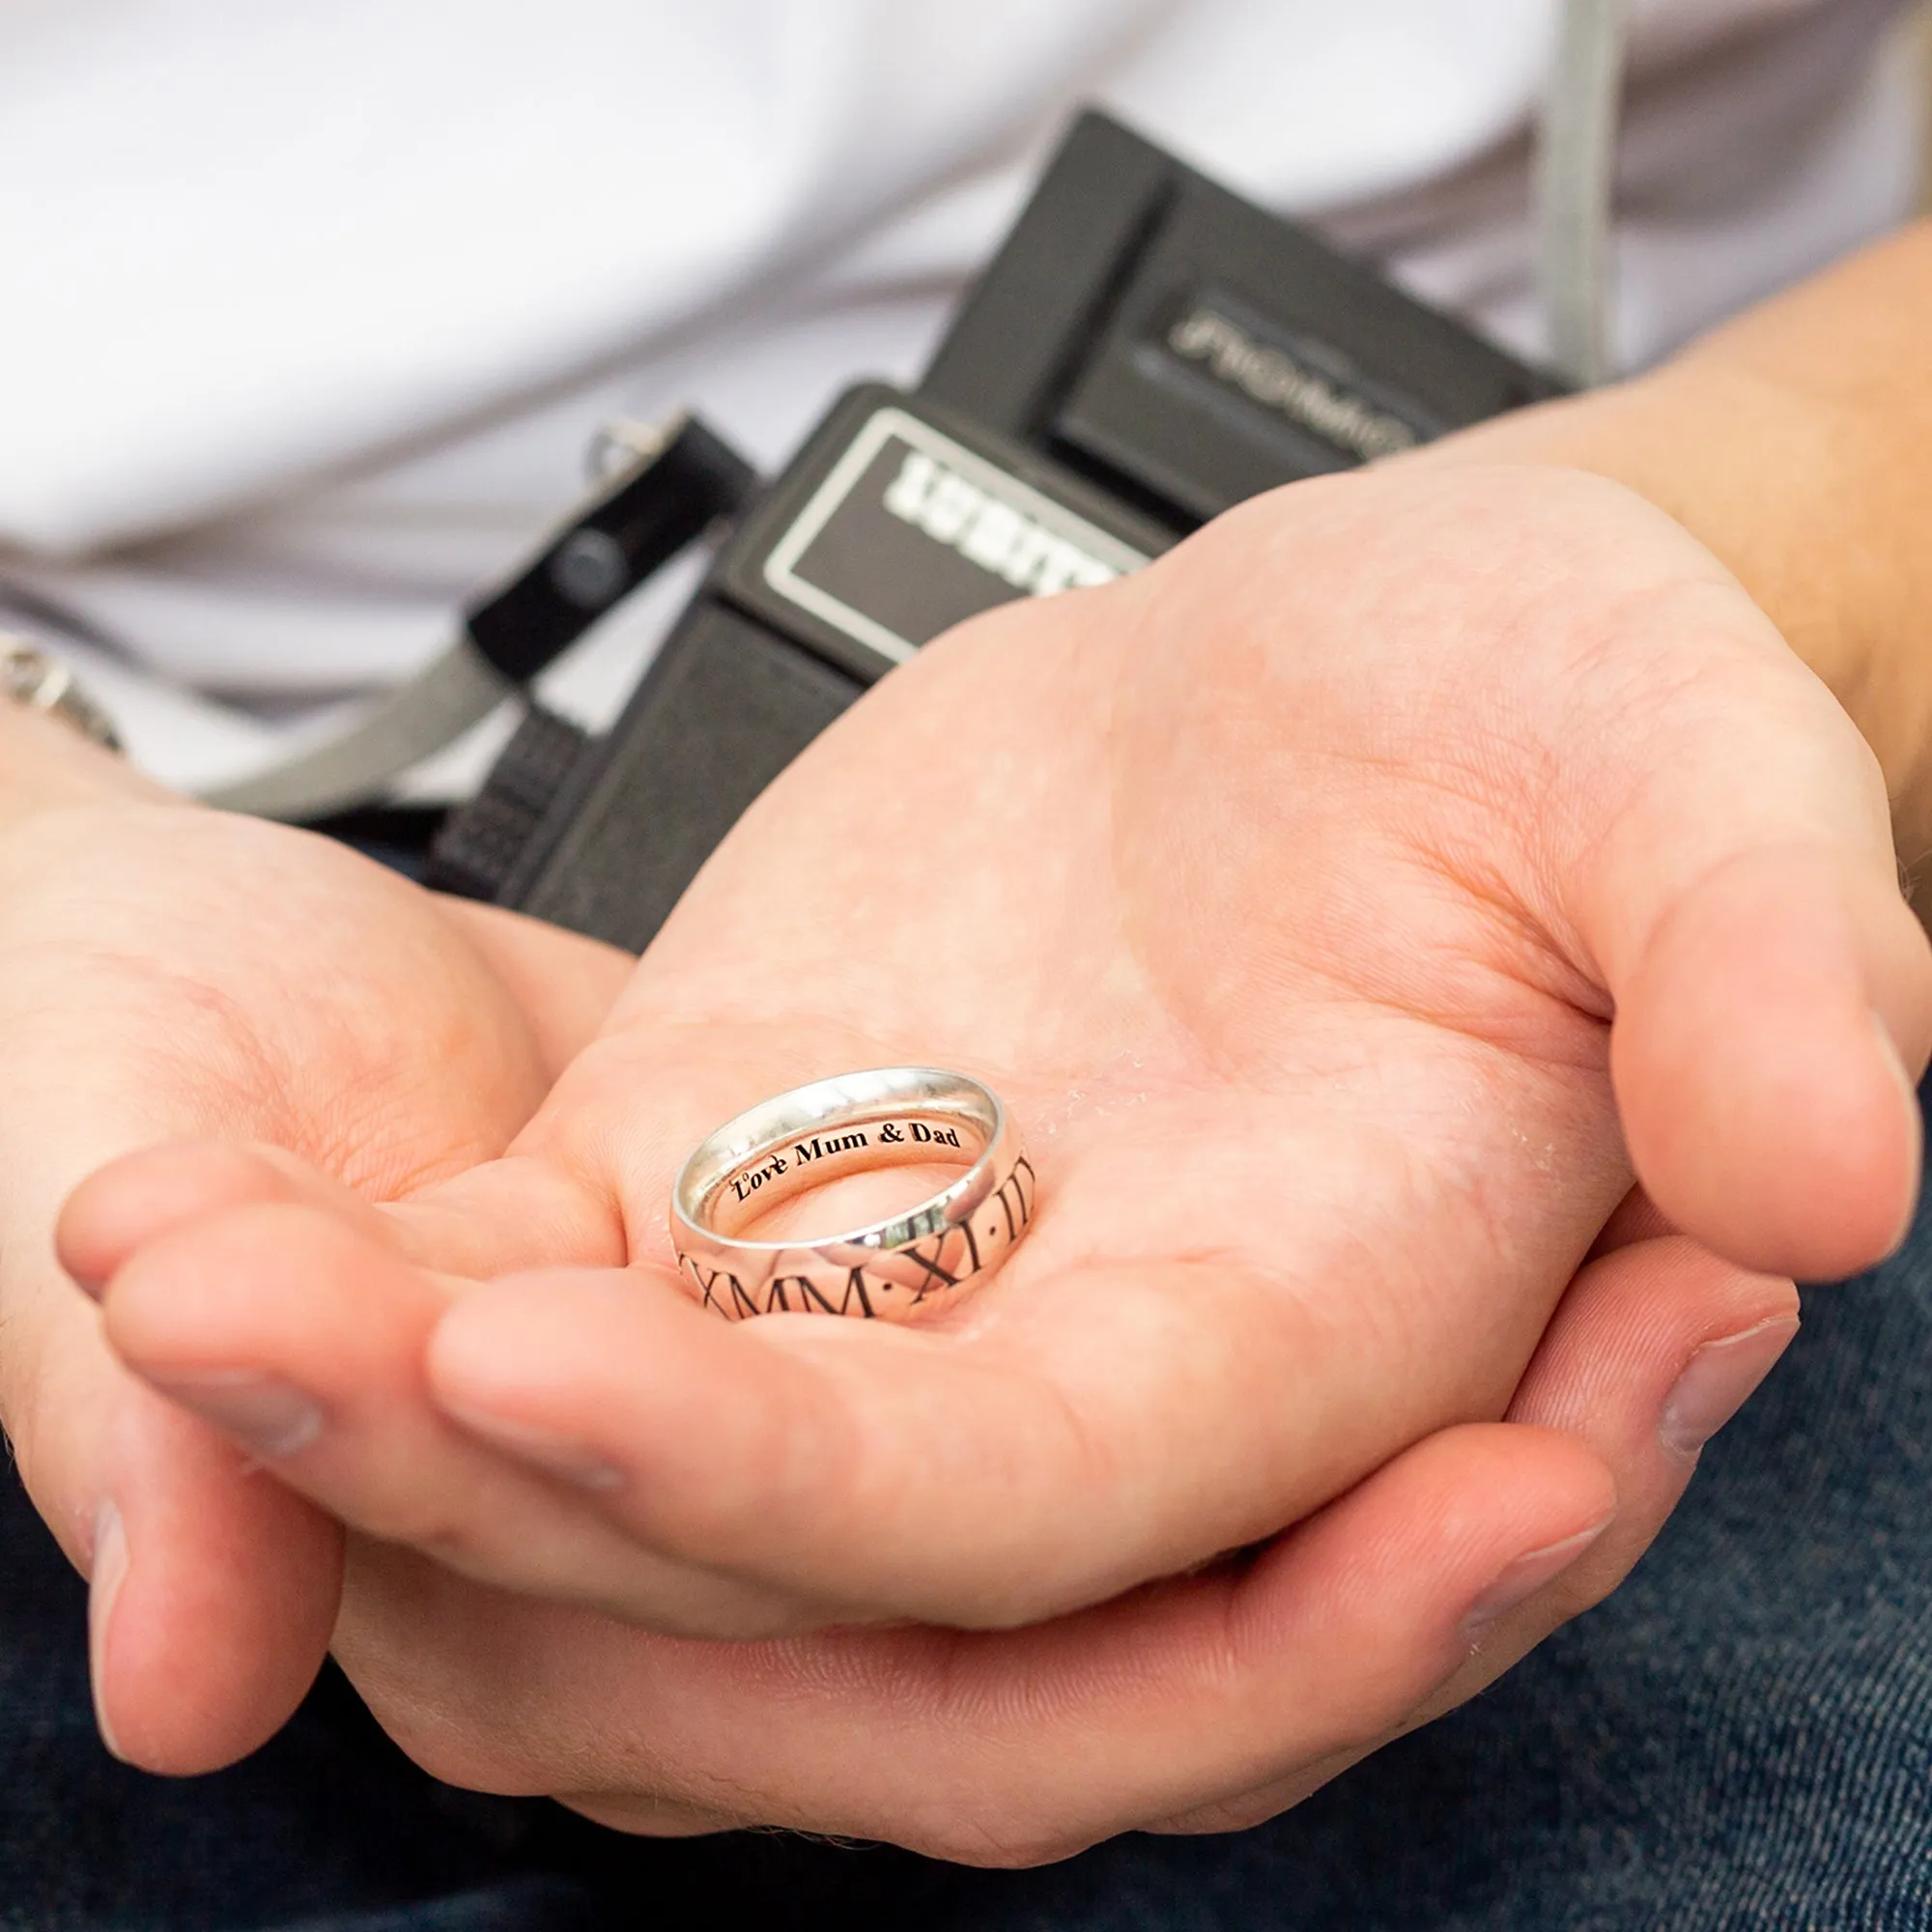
1580;659;1932;1281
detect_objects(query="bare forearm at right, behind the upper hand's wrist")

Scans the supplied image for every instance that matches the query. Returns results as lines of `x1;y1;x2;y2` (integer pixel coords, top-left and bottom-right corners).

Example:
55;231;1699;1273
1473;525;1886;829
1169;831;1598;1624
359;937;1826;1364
1422;222;1932;866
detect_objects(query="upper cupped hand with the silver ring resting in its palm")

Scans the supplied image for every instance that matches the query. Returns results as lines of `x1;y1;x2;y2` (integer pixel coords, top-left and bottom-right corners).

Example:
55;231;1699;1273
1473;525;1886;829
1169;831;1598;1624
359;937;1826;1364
70;469;1932;1634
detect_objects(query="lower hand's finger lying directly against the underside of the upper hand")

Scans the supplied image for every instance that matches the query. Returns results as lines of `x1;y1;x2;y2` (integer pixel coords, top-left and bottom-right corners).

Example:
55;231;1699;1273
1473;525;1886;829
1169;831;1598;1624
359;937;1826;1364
338;1426;1613;1864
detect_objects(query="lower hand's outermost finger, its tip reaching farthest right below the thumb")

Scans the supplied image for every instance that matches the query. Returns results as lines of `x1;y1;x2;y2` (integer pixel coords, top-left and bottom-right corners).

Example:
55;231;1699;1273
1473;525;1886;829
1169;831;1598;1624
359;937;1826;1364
1151;1238;1799;1832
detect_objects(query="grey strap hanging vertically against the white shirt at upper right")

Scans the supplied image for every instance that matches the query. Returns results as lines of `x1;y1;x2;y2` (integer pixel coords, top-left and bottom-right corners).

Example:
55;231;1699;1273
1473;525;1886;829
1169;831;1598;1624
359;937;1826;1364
1534;0;1629;388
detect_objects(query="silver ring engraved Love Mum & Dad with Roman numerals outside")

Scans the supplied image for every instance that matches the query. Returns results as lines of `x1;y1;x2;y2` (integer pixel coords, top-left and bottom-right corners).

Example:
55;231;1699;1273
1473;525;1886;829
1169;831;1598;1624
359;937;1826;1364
670;1066;1034;1321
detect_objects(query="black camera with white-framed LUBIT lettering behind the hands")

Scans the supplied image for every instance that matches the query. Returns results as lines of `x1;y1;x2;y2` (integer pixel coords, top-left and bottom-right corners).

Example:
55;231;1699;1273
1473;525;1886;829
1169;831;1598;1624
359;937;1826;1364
431;114;1559;951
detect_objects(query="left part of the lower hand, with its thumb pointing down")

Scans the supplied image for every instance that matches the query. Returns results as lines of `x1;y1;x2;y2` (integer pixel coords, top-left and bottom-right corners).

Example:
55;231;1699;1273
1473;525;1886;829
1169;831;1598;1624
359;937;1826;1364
0;721;628;1772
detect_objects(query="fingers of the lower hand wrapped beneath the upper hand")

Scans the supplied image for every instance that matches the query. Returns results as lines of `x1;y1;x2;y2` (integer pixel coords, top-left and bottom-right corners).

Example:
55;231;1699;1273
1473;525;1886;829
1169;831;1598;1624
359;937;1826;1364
71;1161;1824;1864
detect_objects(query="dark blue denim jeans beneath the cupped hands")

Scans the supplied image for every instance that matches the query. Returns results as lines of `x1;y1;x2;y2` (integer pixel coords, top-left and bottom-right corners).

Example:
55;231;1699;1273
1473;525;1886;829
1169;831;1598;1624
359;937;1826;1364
11;1097;1932;1932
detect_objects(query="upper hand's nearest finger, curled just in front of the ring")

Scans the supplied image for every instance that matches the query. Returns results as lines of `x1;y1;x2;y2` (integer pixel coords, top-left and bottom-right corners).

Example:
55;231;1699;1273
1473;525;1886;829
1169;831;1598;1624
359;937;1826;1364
427;1236;1569;1627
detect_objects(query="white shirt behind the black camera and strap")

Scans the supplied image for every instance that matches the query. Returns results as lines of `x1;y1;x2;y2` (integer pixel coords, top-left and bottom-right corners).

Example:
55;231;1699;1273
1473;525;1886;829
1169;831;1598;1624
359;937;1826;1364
0;0;1917;782
